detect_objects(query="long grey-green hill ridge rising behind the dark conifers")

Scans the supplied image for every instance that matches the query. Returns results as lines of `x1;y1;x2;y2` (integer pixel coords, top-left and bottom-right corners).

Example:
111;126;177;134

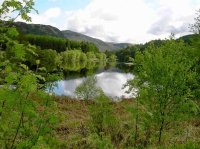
15;22;130;51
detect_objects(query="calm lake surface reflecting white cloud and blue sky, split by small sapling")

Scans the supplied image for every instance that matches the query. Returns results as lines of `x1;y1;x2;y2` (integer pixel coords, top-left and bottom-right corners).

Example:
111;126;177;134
54;68;134;99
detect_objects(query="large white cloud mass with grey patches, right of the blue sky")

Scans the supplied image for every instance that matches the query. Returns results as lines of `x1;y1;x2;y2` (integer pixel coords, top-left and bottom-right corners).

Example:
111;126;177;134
62;0;200;43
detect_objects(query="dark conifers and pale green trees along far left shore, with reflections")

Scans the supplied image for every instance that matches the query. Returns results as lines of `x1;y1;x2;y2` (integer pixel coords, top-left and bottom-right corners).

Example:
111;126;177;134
18;35;107;72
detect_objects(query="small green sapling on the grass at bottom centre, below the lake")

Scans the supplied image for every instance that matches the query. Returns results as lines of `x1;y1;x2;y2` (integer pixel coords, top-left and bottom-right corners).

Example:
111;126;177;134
88;93;118;149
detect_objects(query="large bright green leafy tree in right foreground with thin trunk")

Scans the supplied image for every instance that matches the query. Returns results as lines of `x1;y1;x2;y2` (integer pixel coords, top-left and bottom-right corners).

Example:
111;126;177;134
132;40;197;142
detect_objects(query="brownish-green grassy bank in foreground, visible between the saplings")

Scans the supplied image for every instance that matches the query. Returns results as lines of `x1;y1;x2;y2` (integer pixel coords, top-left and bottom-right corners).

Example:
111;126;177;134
51;97;200;149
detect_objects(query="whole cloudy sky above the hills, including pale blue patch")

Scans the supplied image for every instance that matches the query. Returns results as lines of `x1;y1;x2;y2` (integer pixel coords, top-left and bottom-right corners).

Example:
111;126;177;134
1;0;200;43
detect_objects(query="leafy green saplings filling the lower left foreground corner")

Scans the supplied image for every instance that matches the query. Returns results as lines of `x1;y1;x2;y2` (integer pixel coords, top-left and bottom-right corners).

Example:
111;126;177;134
0;72;56;148
